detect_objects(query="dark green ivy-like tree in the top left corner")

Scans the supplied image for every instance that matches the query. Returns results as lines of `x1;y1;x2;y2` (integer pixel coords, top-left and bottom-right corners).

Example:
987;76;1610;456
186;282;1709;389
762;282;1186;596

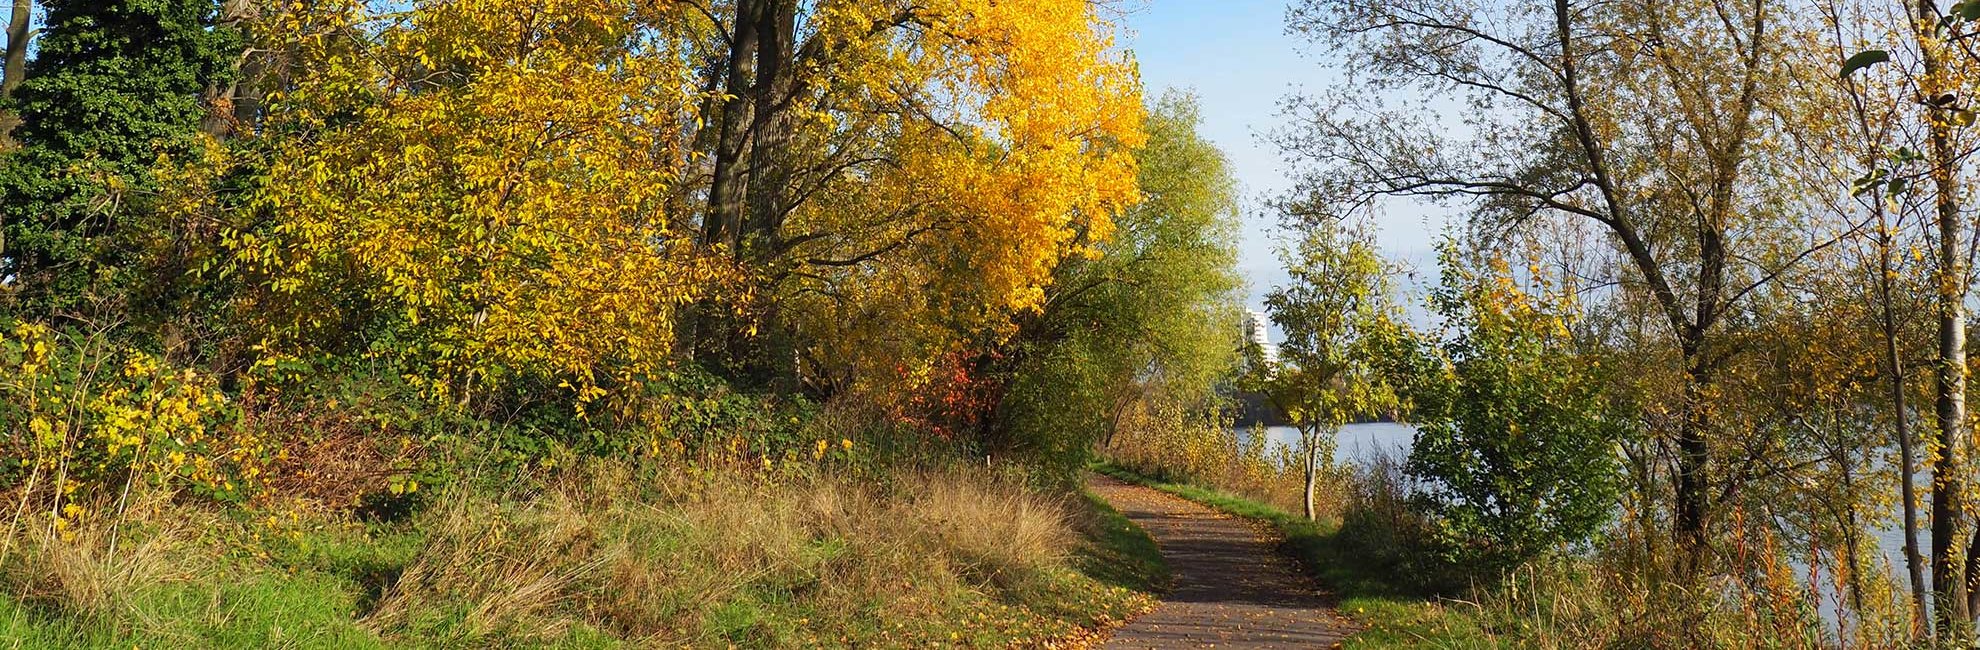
0;0;238;311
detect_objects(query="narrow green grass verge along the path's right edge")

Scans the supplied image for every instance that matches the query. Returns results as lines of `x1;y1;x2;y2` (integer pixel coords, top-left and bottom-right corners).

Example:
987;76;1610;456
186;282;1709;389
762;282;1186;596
1093;462;1503;648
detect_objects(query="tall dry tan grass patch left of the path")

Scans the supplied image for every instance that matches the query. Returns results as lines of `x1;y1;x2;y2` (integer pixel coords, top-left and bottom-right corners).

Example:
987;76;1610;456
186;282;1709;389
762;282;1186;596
366;464;1129;646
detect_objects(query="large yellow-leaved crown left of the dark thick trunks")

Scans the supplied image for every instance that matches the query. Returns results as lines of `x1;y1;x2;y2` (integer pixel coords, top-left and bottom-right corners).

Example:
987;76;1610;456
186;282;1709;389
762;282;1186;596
228;0;731;402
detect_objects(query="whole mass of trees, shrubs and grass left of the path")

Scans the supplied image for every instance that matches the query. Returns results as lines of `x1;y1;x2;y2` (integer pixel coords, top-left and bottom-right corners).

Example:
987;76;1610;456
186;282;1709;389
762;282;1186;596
0;0;1239;648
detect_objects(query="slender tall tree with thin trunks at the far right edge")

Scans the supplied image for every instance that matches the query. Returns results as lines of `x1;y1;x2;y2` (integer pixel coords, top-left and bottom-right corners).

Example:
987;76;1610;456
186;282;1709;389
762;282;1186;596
1824;0;1980;642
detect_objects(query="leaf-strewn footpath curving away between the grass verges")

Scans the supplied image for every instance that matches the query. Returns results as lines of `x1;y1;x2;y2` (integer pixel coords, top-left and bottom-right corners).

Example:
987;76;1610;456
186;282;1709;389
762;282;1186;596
1089;476;1354;648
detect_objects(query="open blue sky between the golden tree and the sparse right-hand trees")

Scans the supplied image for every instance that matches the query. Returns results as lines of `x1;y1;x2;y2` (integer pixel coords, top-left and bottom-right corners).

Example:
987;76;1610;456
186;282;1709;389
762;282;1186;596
1121;0;1441;319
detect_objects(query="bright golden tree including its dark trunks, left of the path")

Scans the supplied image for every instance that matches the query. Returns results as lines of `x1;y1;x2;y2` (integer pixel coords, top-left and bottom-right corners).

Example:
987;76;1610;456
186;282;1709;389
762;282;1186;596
683;0;1142;392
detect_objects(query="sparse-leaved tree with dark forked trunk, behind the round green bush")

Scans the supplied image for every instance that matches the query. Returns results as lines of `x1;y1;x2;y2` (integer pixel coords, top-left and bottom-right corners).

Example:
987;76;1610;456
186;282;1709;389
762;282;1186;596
1281;0;1851;577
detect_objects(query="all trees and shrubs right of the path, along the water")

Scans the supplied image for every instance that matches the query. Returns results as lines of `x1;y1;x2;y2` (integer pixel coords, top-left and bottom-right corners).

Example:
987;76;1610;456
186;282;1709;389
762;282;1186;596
1115;0;1980;648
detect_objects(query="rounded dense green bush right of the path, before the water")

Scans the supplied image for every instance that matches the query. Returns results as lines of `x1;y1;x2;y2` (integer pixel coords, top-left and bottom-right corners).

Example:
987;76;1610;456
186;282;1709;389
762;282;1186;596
1398;246;1628;573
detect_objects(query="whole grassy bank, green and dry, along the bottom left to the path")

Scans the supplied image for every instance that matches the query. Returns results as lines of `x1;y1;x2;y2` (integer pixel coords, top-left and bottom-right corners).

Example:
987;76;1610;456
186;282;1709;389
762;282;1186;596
0;453;1166;648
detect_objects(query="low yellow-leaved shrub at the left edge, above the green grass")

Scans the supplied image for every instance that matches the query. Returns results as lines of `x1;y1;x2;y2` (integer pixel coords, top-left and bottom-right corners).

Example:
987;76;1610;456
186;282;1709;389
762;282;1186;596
0;323;253;531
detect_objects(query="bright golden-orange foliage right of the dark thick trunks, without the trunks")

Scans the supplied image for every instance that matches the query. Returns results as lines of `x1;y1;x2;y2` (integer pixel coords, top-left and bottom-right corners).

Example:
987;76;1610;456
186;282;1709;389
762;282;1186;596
778;0;1144;384
